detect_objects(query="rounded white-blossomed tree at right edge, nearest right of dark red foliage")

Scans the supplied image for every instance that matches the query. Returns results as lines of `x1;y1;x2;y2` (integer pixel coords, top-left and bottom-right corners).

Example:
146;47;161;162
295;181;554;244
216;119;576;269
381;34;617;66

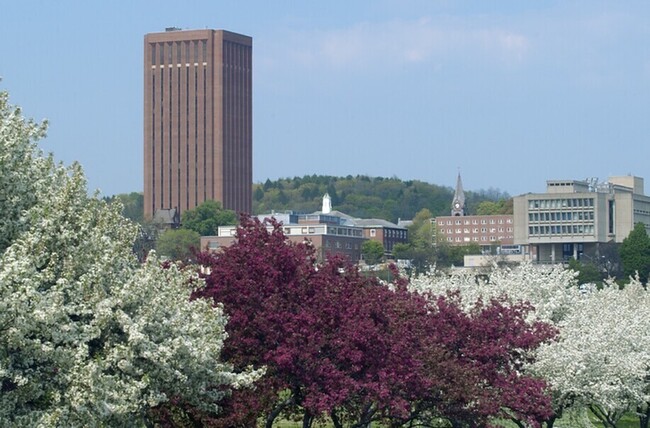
532;279;650;427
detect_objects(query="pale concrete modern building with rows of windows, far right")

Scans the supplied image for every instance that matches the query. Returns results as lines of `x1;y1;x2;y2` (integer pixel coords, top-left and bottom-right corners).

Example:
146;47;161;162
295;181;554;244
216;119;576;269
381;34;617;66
513;176;650;263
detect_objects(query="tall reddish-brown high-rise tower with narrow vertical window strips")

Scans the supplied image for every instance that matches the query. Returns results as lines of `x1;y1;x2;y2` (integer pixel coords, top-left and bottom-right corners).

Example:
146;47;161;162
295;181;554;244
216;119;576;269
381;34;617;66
144;28;253;218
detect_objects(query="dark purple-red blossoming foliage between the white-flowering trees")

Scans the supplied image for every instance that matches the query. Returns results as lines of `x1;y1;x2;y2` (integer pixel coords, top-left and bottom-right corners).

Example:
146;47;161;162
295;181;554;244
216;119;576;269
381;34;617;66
189;218;554;427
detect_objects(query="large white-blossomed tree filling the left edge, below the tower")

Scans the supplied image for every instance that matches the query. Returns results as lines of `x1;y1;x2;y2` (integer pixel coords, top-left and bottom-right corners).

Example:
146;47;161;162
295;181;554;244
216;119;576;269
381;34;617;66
0;93;261;426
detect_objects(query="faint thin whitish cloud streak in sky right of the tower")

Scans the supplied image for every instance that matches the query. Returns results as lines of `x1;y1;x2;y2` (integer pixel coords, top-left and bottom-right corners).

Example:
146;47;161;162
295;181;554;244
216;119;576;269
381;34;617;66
266;18;529;70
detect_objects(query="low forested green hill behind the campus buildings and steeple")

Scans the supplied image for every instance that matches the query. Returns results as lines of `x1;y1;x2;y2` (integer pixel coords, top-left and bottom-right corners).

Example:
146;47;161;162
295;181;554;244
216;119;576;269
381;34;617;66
253;175;509;222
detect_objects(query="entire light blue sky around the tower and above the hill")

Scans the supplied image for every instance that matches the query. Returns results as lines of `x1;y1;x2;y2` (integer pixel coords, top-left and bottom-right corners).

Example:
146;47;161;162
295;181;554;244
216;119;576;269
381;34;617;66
0;0;650;195
